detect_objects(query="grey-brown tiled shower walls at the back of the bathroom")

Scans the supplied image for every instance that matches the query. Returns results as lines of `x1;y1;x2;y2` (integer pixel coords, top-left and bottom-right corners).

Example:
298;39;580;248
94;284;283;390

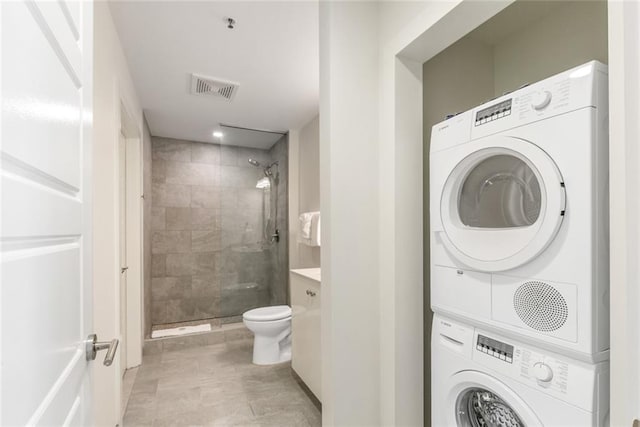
145;135;288;335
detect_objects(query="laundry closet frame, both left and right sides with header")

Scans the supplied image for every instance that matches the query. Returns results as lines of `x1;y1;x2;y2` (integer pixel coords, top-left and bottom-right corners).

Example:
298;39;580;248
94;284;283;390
379;0;640;426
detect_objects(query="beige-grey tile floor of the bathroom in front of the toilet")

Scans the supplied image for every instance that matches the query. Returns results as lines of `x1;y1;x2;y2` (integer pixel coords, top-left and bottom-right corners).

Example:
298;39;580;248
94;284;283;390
124;339;321;427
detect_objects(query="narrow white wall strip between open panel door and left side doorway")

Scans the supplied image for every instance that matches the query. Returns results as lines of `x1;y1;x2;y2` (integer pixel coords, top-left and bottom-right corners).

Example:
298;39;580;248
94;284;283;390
93;2;142;427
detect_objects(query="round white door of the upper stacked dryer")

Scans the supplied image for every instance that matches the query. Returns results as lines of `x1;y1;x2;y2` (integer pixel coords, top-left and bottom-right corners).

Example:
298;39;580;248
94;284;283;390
440;137;565;271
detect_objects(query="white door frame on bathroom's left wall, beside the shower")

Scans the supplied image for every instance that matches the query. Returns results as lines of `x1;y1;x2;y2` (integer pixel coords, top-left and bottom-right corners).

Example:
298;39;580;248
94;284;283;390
115;99;144;369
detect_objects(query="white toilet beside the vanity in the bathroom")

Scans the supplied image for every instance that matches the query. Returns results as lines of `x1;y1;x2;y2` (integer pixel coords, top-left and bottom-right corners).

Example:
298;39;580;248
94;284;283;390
242;305;291;365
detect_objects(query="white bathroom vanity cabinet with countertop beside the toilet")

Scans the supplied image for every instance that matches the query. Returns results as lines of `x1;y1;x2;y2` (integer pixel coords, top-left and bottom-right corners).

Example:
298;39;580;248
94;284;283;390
289;268;322;401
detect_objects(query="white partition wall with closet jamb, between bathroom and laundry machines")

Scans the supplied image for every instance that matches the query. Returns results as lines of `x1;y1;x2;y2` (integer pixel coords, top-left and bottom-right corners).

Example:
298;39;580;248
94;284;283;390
320;1;509;425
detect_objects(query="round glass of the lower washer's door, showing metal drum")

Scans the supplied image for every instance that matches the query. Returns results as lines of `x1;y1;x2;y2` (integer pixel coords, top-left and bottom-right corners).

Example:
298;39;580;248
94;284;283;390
456;388;525;427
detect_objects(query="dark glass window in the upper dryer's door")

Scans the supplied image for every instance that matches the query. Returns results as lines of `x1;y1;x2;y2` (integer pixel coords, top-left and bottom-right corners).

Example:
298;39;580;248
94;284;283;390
458;154;542;228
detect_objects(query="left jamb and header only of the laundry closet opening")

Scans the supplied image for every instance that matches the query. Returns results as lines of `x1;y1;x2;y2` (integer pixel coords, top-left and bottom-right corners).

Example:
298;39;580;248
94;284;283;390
378;0;514;425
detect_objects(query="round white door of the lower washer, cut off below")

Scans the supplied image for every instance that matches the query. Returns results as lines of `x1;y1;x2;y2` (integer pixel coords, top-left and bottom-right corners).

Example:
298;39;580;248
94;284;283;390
446;371;542;427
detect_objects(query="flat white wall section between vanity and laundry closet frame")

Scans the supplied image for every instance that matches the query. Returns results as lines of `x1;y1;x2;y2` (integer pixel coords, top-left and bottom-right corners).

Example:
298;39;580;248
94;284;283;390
320;2;380;426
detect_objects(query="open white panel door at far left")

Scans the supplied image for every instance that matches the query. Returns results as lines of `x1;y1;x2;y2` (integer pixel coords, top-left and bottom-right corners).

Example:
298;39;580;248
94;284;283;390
0;0;93;426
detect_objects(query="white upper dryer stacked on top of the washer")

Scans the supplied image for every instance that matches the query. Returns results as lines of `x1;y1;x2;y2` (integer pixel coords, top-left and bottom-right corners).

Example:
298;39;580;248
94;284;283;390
430;61;609;361
